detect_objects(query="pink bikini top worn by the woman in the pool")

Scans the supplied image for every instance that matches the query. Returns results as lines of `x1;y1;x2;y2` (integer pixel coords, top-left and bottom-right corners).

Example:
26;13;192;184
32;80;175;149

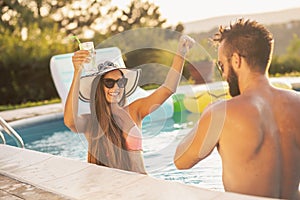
126;125;143;151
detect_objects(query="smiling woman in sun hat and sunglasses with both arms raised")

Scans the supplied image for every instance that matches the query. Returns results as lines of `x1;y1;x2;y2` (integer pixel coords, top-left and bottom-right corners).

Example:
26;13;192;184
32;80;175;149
64;36;194;174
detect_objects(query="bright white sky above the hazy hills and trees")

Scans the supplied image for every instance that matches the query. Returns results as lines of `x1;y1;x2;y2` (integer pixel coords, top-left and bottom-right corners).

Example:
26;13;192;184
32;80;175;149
112;0;300;25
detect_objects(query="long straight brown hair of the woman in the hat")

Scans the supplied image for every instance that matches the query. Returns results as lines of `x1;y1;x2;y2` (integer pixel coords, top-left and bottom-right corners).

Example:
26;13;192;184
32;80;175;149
88;71;132;171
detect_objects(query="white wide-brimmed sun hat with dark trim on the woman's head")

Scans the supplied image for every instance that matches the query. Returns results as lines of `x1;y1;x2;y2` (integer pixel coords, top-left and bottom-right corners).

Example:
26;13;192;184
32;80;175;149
79;61;141;102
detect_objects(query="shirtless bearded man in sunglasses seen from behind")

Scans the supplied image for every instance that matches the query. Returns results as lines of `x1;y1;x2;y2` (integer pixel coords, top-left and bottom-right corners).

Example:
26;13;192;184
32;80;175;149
174;19;300;199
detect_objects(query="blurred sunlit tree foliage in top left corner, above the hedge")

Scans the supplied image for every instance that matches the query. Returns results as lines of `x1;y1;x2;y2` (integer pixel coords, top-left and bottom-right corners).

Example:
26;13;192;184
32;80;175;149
0;0;116;35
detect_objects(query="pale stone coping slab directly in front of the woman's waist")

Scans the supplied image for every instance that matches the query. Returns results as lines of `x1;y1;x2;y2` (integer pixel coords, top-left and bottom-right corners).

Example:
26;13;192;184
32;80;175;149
42;164;147;199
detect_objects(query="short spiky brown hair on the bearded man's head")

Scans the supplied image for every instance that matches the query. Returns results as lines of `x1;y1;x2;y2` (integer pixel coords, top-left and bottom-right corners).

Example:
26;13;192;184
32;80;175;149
212;18;274;73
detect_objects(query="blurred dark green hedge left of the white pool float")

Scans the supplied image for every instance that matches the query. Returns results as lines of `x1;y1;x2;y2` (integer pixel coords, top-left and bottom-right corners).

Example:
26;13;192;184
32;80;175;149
0;25;74;105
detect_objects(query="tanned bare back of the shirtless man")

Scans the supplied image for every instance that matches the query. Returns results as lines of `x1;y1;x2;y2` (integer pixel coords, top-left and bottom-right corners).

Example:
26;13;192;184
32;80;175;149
218;84;300;199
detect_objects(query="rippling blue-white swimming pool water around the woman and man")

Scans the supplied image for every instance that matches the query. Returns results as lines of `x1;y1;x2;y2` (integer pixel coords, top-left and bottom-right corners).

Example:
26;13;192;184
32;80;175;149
6;113;224;191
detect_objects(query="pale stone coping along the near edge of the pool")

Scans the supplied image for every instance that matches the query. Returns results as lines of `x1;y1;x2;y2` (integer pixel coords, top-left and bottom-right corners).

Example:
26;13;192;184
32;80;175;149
0;144;278;200
